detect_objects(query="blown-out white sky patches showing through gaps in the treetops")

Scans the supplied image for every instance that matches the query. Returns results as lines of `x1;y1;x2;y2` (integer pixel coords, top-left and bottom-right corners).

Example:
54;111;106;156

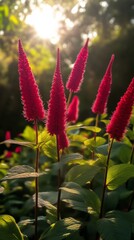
26;0;98;44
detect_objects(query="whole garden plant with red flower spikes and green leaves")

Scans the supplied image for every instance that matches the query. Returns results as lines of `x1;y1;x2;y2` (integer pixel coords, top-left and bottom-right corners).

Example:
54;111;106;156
0;39;134;240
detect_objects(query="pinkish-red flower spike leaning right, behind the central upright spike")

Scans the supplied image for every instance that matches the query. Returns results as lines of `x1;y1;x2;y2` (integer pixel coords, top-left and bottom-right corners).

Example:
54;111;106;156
66;38;89;92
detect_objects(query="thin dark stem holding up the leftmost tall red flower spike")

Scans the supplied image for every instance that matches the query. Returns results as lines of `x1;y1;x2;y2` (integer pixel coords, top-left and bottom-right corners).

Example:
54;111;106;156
35;121;39;240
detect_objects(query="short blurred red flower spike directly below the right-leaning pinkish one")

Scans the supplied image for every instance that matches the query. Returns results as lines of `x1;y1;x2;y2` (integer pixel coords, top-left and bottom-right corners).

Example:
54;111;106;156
67;96;80;123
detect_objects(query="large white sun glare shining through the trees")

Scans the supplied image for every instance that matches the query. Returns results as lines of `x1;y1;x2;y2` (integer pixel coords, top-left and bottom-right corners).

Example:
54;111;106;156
26;4;63;44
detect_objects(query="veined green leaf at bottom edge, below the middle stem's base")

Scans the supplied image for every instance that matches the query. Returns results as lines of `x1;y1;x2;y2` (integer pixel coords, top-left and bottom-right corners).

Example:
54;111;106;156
40;218;81;240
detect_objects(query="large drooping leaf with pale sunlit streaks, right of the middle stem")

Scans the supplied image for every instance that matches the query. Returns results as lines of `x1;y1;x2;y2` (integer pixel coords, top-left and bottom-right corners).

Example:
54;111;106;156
61;182;100;214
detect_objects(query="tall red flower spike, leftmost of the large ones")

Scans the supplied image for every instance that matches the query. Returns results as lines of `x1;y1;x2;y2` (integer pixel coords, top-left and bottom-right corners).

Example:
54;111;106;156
18;40;45;121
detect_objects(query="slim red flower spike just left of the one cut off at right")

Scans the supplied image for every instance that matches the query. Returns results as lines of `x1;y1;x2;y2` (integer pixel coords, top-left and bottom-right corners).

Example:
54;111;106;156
91;55;114;114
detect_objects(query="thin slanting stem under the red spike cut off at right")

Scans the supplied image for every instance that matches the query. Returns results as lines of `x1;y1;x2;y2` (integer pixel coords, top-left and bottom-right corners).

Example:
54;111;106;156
99;139;114;218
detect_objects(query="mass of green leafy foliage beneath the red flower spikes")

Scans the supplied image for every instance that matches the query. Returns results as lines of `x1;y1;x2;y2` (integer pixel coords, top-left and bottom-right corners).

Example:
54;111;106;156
0;109;134;240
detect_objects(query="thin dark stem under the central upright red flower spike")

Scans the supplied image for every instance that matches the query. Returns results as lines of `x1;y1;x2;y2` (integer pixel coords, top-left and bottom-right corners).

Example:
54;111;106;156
56;135;61;221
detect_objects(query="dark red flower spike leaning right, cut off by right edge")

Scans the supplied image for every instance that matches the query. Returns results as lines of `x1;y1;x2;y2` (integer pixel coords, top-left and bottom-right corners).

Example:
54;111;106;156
106;78;134;141
